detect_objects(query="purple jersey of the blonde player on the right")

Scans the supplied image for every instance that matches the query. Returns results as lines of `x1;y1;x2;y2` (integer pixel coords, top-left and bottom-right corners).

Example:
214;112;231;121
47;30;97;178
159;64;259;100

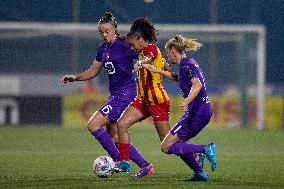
178;58;211;114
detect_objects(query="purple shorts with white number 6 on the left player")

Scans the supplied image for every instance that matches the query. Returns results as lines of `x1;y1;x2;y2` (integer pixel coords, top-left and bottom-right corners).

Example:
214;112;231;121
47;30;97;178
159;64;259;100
98;88;136;122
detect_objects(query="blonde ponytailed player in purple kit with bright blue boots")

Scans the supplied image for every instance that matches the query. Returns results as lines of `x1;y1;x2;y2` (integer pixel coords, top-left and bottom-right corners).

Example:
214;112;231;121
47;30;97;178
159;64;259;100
143;35;216;181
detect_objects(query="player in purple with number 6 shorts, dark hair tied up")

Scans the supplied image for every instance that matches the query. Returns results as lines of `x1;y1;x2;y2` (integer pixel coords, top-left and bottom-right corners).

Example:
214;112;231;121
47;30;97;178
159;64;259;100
61;12;152;173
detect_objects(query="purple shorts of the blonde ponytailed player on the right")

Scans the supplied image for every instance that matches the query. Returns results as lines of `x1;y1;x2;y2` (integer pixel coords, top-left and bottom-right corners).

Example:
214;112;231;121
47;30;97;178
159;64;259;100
170;105;212;142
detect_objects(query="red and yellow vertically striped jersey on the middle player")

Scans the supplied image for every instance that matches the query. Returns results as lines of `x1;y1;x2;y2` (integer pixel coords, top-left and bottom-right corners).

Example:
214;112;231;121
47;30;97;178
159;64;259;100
136;43;169;105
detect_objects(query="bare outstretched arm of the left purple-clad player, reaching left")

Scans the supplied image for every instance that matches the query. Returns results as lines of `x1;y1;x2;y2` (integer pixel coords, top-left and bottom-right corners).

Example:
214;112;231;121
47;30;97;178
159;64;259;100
61;60;102;84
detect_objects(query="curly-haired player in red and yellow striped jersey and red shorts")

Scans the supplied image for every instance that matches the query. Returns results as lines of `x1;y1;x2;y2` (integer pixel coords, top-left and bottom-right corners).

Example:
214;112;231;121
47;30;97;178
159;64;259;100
114;17;170;178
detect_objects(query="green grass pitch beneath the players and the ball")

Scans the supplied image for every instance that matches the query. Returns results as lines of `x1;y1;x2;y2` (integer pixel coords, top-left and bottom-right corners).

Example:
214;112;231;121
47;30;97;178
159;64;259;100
0;126;284;189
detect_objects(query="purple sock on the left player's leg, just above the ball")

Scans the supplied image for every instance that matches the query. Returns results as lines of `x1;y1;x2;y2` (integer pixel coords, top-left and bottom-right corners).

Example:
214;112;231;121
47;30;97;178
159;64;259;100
92;128;119;161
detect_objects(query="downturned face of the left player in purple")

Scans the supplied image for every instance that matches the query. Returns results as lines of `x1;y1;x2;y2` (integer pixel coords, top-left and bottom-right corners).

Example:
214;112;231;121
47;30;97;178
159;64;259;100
98;23;116;43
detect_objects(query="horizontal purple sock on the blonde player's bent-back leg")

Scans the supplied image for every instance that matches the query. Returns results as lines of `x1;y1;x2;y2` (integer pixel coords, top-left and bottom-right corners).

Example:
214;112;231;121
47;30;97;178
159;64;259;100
168;143;204;156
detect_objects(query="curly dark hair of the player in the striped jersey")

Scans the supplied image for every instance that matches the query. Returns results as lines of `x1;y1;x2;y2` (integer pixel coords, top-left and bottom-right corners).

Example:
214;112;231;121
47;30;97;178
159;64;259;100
127;17;158;42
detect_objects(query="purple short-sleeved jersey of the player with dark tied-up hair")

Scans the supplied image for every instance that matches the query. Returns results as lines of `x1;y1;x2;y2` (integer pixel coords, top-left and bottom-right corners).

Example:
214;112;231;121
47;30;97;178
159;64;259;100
96;38;139;94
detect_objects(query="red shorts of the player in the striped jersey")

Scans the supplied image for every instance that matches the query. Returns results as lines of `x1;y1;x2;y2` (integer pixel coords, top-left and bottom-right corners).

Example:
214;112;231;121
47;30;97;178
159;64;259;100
131;99;170;121
